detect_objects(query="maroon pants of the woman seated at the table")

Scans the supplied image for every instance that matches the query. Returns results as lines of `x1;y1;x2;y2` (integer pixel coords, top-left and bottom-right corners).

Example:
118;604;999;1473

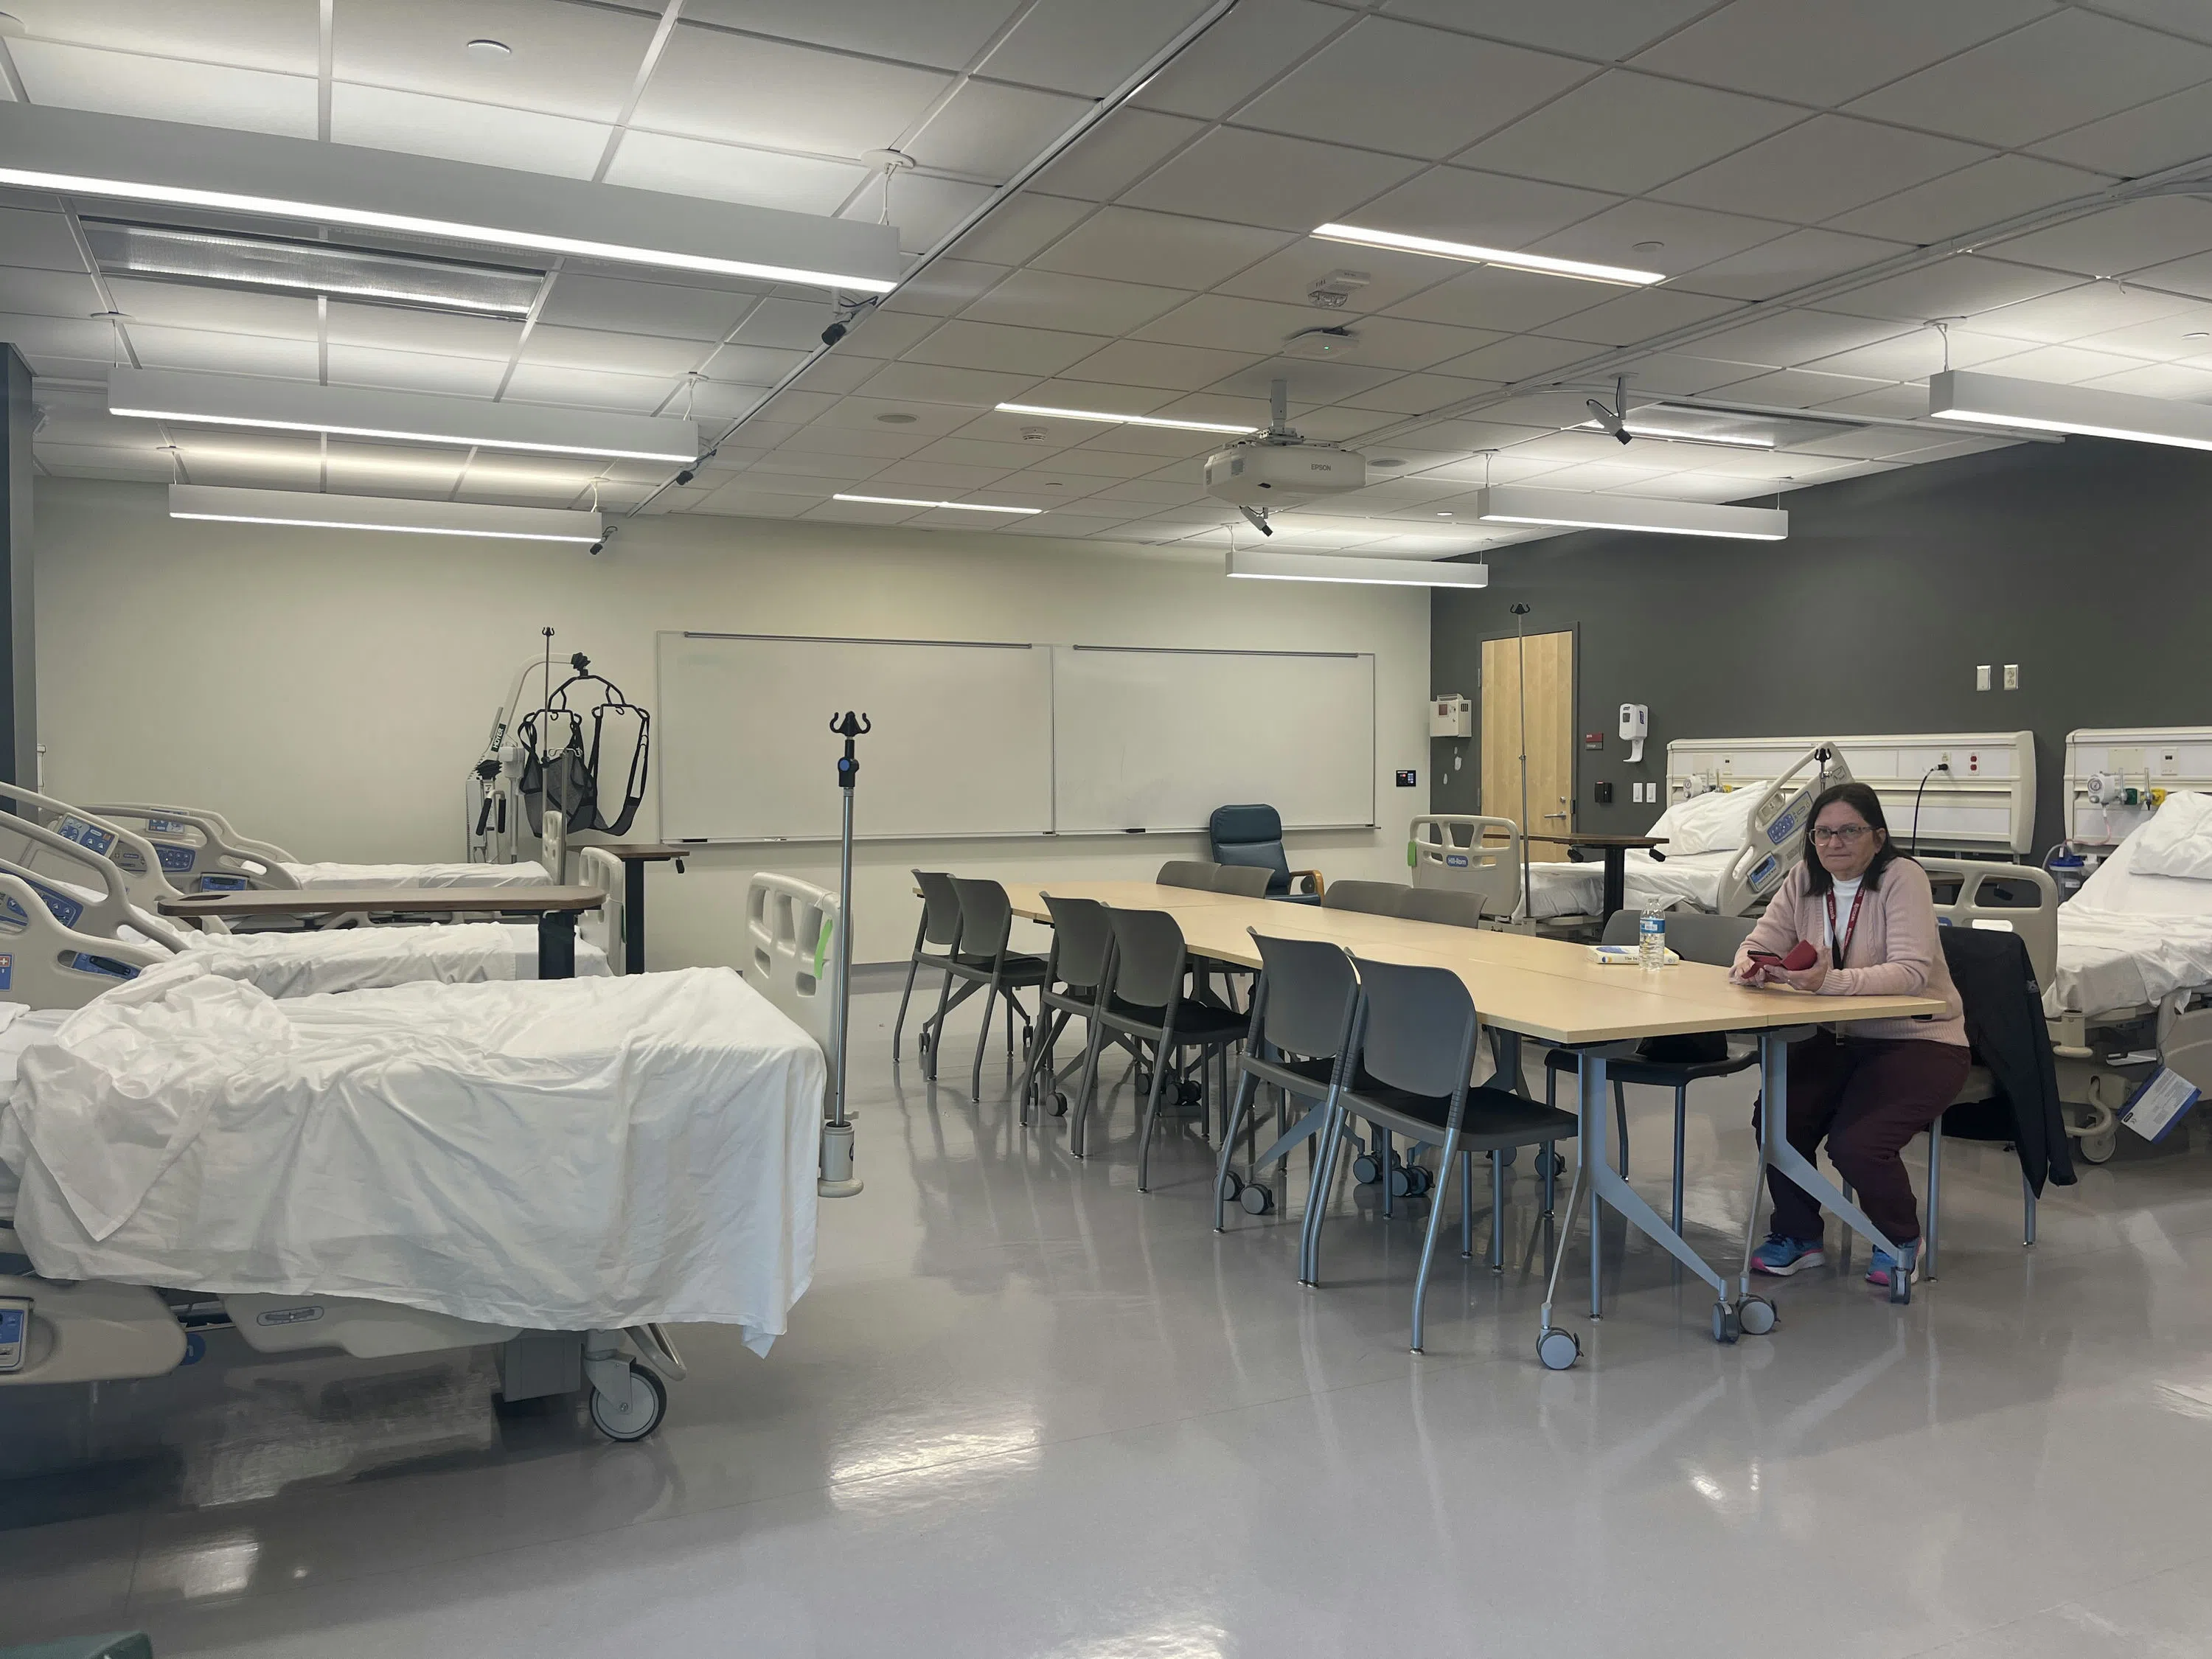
1752;1031;1969;1245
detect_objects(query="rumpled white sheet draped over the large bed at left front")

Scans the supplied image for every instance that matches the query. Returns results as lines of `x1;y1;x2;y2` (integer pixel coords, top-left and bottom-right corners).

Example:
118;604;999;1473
0;960;827;1352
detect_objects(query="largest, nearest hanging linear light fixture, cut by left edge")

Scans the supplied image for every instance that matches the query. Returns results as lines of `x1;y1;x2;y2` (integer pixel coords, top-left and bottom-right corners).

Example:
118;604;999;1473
0;104;900;294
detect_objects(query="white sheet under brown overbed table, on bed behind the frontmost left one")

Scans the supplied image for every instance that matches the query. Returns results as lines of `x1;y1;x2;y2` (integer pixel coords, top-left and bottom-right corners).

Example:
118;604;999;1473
186;922;613;998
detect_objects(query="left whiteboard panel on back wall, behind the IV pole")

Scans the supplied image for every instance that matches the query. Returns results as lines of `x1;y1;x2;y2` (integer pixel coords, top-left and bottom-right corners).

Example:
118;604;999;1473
653;633;1053;841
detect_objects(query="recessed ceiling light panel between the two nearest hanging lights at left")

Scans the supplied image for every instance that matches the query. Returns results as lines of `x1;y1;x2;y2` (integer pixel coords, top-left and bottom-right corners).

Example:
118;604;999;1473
84;219;544;319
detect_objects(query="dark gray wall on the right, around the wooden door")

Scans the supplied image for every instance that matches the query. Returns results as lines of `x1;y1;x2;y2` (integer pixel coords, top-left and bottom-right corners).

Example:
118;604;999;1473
1429;438;2212;856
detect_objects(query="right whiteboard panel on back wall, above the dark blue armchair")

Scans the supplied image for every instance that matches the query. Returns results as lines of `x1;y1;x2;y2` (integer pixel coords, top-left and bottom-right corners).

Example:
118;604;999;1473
1053;646;1376;834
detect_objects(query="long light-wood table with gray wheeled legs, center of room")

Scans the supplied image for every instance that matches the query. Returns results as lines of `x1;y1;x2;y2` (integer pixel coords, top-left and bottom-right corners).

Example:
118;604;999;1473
1004;880;1944;1365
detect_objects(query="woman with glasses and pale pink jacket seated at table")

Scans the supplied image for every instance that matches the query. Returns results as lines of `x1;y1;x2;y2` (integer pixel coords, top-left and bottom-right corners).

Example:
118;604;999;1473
1734;783;1966;1287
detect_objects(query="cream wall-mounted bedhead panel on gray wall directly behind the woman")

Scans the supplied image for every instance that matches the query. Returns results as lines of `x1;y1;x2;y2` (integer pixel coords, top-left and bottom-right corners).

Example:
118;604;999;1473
1666;732;2035;858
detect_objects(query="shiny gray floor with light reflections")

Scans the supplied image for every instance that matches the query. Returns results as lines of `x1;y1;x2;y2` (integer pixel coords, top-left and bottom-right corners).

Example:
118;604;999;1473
0;995;2212;1659
